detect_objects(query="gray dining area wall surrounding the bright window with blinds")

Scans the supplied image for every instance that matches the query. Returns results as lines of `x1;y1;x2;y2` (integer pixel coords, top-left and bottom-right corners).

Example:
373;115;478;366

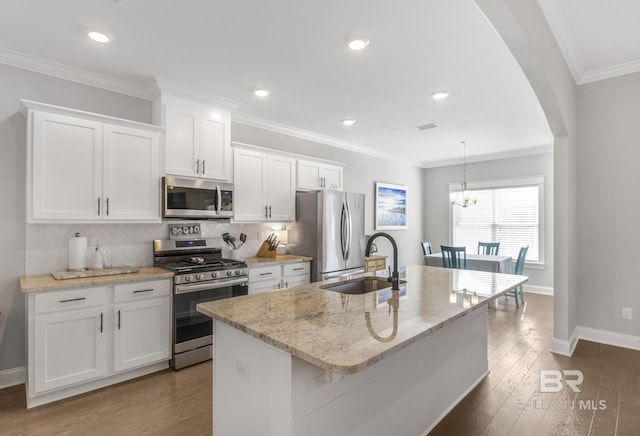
424;153;553;292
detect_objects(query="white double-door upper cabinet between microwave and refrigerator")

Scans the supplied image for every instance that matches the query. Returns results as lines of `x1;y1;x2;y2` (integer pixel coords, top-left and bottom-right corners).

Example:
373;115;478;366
233;148;296;222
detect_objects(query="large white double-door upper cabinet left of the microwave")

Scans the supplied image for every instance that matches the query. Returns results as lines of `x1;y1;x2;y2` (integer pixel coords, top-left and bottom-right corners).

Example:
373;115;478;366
23;101;161;222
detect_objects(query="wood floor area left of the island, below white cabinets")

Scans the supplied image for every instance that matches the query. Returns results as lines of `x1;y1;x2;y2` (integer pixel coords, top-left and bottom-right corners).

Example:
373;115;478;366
0;361;212;436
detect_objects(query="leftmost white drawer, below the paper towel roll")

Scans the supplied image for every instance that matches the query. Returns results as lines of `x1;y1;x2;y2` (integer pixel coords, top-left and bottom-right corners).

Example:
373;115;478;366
34;287;107;313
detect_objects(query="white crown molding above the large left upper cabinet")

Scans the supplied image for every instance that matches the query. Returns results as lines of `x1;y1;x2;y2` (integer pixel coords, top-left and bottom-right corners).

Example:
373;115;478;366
0;47;150;100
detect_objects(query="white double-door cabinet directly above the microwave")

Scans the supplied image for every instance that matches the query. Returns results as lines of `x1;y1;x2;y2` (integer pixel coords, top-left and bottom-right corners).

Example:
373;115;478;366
153;97;231;181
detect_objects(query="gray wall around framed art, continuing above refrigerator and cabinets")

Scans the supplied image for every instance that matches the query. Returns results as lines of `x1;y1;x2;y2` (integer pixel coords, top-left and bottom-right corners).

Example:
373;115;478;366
231;123;424;265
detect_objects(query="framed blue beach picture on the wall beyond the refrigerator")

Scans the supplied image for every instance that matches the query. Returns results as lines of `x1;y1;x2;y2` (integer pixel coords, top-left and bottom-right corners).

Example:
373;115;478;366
376;182;407;230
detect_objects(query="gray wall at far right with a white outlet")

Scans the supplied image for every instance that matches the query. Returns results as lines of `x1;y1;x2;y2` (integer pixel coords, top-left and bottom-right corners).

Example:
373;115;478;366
575;73;640;337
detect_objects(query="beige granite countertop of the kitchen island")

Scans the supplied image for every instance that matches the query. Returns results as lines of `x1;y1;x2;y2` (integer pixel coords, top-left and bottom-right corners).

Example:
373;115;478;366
197;265;528;374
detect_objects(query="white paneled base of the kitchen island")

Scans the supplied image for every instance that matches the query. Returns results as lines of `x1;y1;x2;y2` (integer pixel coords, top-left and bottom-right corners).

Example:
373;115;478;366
213;305;488;436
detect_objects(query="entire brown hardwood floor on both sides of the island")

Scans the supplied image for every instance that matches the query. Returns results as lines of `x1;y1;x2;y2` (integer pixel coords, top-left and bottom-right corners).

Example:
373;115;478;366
0;294;640;436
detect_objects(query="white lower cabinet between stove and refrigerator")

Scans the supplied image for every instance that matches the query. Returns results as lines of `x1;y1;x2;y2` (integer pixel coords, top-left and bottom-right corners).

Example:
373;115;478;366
249;262;311;294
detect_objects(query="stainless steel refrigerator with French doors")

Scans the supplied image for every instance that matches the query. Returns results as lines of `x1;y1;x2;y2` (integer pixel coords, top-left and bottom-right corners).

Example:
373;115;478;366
287;191;365;281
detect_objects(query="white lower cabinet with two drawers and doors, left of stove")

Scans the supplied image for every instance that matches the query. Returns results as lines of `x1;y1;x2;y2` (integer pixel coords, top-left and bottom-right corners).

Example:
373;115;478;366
27;279;171;407
